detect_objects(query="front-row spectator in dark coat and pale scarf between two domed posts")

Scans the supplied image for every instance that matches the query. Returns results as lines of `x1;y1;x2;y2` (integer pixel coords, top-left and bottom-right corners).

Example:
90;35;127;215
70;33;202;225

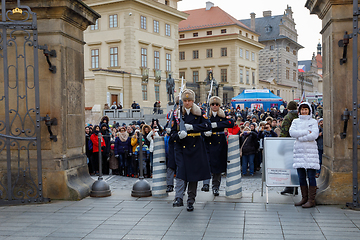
114;127;132;176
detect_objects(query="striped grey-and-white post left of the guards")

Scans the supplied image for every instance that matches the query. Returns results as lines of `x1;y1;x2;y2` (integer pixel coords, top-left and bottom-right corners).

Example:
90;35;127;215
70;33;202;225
152;137;168;197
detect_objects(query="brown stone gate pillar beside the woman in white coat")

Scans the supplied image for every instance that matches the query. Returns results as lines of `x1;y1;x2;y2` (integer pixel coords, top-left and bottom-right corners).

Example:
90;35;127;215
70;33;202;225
305;0;360;204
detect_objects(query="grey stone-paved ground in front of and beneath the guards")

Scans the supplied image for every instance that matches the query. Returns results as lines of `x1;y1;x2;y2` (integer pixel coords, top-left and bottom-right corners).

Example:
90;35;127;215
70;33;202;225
0;174;360;240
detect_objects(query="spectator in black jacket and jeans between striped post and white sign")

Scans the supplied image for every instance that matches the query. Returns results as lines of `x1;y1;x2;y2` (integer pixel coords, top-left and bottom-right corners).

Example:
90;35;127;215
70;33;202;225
240;127;258;176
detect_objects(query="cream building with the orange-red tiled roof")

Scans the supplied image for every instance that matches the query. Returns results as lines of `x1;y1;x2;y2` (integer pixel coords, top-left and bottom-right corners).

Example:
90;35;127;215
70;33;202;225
179;2;263;103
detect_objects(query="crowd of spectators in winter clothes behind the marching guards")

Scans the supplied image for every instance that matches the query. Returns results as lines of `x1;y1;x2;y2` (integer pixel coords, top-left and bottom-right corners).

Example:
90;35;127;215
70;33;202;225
85;101;323;177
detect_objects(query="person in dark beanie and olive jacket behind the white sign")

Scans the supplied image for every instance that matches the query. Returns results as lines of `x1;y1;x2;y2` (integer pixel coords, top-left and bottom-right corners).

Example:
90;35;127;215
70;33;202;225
280;101;298;195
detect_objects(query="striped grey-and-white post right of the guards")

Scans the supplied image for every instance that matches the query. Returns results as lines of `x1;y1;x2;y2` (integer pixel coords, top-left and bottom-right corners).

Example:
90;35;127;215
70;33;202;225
226;135;242;198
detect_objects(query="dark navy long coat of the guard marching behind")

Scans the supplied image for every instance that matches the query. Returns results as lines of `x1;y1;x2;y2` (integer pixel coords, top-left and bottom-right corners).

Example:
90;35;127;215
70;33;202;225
205;109;234;174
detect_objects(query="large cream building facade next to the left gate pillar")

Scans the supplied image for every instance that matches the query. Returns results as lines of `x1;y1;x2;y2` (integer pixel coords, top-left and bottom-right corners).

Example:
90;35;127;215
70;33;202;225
84;0;187;122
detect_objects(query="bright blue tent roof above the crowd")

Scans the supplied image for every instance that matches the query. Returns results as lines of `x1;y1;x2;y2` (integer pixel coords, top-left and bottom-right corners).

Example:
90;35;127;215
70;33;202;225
231;89;282;102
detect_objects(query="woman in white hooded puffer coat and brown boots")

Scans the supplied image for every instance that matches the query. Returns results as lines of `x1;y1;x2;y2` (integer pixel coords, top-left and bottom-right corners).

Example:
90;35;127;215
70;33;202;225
289;102;320;208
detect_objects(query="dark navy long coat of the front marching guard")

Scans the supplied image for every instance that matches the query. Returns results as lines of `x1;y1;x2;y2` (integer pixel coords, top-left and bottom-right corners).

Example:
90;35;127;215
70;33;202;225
172;104;211;182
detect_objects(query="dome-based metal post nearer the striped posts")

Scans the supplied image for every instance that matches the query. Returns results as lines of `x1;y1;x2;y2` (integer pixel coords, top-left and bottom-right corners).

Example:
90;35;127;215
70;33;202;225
131;132;152;197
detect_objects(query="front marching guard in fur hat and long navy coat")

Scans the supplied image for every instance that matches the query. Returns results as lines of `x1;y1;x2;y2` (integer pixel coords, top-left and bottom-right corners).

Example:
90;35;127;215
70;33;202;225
172;89;211;211
